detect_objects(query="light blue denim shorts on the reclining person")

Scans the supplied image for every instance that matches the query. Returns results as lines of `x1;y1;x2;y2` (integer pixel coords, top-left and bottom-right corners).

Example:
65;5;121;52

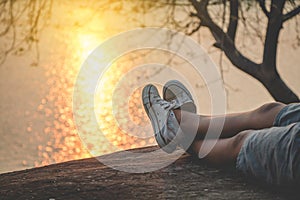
236;103;300;185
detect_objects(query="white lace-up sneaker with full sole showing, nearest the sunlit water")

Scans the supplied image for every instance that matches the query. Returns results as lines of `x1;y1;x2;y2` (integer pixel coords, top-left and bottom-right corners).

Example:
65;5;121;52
142;84;181;153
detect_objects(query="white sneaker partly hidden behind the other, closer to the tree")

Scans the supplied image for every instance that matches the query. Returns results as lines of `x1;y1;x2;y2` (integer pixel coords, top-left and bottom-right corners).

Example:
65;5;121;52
163;80;197;113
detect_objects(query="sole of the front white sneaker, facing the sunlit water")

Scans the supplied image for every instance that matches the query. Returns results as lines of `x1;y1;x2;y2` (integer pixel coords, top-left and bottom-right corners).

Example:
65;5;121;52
142;84;176;153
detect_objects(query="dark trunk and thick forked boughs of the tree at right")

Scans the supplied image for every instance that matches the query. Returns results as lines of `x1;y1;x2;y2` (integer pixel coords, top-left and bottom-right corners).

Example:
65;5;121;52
190;0;300;103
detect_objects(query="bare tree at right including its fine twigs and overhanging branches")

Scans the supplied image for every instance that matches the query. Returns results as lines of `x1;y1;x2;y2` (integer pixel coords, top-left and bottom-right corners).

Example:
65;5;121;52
127;0;300;103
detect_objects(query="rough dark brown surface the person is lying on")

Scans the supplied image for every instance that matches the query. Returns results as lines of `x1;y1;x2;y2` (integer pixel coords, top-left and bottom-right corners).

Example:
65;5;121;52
0;147;300;200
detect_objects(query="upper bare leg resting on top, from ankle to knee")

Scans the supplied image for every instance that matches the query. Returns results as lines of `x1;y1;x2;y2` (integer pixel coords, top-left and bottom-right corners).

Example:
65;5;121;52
174;102;285;139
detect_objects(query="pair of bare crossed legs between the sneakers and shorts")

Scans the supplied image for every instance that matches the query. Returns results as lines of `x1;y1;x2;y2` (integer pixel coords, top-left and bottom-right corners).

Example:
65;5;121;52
174;103;285;165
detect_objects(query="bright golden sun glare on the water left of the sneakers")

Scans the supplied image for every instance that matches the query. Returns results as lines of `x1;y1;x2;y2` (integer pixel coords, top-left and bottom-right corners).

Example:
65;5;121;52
36;15;154;166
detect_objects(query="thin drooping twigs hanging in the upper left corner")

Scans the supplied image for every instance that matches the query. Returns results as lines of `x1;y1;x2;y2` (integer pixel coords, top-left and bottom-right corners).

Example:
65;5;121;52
0;0;52;64
